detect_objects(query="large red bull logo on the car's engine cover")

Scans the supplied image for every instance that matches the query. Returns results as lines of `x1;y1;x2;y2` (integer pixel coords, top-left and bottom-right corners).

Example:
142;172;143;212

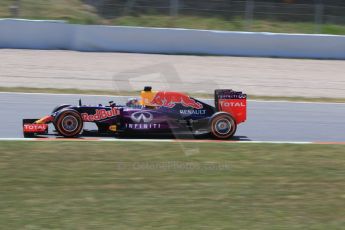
151;92;203;109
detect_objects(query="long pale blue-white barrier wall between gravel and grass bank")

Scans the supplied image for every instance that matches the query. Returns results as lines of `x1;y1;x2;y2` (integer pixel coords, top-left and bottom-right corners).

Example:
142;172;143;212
0;19;345;59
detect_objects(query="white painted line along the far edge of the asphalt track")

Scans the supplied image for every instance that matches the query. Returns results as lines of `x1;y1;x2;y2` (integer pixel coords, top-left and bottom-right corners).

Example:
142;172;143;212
0;92;345;105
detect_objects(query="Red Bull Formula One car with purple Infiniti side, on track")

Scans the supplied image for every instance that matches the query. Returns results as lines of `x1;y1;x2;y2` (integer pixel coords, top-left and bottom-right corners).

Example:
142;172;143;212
23;87;247;139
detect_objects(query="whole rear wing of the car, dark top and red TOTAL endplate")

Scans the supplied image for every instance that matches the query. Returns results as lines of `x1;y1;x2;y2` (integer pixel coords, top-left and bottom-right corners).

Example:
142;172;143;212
214;89;247;124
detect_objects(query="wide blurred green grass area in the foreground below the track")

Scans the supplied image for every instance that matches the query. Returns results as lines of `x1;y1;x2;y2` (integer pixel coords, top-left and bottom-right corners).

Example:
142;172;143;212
0;142;345;230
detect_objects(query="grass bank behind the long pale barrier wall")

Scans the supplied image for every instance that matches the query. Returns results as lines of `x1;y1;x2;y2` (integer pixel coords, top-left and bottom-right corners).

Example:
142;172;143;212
0;0;345;35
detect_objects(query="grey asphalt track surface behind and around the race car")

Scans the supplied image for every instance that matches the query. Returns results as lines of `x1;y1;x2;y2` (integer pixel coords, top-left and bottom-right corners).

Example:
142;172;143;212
0;93;345;142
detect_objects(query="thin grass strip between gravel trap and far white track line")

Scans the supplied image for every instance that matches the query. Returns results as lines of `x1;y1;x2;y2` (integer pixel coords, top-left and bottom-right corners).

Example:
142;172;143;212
0;87;345;103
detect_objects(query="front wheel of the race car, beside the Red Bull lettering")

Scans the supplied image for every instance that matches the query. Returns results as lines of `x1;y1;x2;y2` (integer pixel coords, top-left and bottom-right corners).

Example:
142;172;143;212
54;109;83;138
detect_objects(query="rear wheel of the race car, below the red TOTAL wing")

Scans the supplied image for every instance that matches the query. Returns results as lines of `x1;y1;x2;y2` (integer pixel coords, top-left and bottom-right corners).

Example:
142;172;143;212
209;113;237;140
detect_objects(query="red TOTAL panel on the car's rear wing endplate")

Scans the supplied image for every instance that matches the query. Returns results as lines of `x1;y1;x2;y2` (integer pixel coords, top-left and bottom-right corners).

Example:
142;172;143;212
218;98;247;124
